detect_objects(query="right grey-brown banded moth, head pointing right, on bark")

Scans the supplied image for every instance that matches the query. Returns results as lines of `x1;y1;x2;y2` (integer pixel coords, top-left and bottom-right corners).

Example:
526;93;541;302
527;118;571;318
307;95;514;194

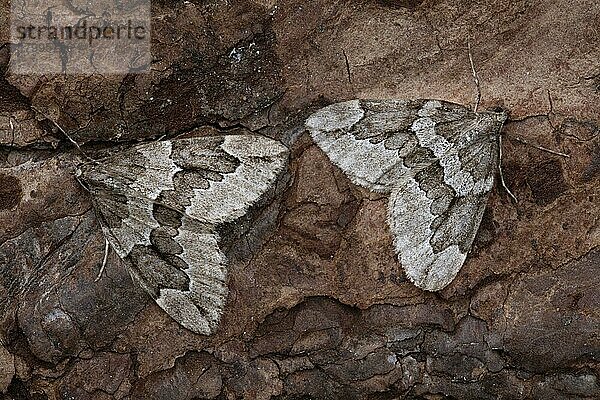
305;100;507;291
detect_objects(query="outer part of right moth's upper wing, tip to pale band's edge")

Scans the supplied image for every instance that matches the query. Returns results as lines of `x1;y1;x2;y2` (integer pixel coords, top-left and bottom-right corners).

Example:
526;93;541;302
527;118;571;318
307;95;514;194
305;100;434;193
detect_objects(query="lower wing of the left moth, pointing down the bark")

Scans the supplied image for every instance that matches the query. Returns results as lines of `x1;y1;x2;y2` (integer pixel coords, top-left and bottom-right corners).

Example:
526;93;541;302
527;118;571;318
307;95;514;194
94;197;227;335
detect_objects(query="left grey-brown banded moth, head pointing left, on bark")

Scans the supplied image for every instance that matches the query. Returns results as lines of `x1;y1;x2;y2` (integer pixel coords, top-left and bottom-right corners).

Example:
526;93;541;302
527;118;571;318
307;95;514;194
77;135;288;335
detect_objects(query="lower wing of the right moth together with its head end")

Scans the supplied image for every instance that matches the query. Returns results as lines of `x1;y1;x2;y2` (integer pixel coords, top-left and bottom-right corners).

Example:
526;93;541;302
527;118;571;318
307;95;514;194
388;103;505;291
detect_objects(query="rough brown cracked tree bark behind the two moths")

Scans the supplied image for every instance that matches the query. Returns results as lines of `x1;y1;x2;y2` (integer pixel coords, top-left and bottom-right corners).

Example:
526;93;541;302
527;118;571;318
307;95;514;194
0;0;600;400
